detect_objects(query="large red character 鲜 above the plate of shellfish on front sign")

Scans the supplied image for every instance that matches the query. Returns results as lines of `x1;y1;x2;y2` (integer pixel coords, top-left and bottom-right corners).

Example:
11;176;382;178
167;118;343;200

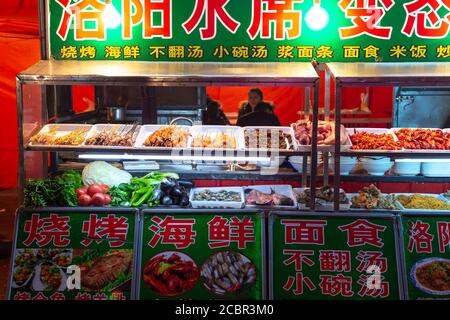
208;216;255;249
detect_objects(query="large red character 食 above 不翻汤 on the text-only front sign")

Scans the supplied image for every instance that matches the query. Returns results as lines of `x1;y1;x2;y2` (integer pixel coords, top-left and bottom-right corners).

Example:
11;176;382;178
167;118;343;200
339;219;386;248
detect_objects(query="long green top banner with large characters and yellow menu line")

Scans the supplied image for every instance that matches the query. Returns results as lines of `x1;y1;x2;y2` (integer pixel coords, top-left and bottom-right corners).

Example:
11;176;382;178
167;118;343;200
48;0;450;62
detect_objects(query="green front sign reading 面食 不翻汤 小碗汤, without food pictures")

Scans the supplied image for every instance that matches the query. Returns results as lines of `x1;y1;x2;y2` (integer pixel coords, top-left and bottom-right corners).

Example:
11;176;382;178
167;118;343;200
269;214;400;300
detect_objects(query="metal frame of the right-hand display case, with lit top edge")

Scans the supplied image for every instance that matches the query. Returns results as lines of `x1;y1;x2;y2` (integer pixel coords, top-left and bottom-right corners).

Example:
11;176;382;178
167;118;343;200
326;62;450;212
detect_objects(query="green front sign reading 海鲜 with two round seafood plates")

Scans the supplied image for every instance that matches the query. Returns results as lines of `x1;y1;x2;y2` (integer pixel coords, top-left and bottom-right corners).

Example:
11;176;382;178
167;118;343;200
138;210;265;300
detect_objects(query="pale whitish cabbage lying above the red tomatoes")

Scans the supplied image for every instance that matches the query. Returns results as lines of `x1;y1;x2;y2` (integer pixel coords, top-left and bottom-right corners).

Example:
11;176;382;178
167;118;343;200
82;161;132;188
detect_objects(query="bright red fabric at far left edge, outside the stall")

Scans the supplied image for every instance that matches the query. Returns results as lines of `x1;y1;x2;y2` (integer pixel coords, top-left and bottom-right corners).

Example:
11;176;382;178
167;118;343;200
0;0;39;188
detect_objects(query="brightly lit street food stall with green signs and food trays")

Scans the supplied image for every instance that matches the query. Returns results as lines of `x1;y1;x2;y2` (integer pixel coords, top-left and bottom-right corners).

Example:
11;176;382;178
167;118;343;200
8;0;450;300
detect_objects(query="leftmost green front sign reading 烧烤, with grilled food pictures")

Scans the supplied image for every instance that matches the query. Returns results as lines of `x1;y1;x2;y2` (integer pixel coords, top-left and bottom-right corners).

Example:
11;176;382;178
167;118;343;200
9;210;137;300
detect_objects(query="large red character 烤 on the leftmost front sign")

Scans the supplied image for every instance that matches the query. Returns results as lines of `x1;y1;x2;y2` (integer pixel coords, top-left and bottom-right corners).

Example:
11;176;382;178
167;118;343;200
81;214;128;248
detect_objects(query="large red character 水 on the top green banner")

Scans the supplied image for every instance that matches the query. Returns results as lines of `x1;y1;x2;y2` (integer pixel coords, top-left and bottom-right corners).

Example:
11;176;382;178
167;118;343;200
182;0;240;40
